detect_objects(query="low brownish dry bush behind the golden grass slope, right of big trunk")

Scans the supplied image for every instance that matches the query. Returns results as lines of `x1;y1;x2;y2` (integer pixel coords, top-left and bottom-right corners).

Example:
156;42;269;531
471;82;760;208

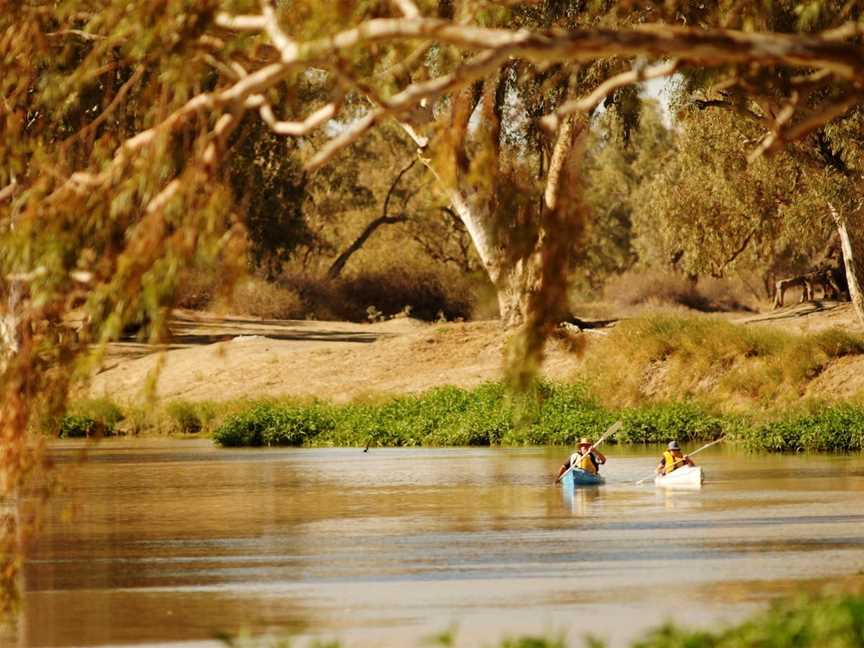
603;270;753;312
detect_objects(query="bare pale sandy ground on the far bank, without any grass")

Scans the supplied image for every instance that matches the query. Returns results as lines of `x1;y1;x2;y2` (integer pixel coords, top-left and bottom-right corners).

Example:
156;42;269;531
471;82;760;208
90;302;864;402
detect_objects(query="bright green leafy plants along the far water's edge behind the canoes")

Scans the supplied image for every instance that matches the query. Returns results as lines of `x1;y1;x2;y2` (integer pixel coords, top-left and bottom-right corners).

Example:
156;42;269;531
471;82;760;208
213;383;864;452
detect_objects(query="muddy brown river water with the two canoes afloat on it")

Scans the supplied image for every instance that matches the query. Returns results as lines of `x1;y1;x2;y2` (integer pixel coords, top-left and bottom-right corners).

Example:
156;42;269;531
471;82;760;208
15;441;864;647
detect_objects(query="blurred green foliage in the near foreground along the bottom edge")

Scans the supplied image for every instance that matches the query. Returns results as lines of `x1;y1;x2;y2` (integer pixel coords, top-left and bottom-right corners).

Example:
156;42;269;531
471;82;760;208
223;594;864;648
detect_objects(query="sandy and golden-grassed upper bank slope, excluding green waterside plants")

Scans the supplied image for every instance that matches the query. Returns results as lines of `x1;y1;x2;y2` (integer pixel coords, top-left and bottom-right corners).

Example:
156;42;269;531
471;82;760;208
86;303;864;410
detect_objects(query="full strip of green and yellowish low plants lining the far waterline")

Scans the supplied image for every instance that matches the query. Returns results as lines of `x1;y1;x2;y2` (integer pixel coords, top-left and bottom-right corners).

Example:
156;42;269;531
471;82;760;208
60;383;864;452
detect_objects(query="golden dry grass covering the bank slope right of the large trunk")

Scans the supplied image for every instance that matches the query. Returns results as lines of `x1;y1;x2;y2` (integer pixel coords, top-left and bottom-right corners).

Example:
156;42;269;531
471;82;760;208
579;314;864;411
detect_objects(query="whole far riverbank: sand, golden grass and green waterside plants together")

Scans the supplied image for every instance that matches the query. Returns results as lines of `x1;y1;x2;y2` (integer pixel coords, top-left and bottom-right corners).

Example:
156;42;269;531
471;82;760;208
64;307;864;452
